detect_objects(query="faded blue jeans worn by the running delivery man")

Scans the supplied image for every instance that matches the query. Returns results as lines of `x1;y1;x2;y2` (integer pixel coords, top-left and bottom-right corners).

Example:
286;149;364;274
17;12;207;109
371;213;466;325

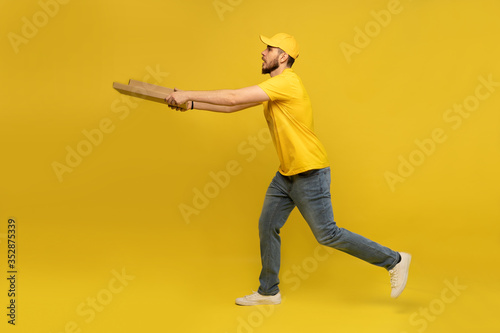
259;167;400;296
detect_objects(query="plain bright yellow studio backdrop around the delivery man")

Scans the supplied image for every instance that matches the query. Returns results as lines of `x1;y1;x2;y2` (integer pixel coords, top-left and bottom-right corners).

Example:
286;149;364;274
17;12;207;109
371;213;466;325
0;0;500;333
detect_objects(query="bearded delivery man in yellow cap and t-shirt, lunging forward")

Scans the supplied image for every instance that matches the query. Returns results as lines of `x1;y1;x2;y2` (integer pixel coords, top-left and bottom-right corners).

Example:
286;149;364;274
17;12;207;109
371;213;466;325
166;33;411;305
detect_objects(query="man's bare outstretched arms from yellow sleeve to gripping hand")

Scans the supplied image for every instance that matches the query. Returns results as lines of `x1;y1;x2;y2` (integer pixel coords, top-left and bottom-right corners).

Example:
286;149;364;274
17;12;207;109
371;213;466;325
166;86;269;112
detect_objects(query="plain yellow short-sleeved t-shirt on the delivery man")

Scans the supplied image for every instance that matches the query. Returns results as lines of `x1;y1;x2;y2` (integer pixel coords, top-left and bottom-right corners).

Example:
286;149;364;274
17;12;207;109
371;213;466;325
258;68;329;176
